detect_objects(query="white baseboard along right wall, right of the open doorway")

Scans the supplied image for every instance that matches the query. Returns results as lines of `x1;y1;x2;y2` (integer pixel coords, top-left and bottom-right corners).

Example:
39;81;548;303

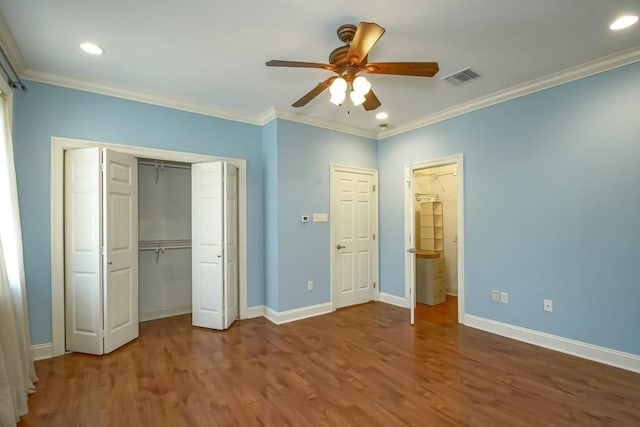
464;314;640;373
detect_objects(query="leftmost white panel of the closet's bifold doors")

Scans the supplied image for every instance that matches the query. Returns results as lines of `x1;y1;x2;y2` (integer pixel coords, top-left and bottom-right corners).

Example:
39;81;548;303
64;148;103;355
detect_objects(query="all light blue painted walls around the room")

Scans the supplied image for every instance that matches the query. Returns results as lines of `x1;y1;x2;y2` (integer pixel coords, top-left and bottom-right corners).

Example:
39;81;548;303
14;64;640;354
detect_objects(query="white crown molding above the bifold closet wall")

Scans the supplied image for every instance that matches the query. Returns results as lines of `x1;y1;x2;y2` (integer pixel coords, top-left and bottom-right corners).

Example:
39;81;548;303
22;69;260;125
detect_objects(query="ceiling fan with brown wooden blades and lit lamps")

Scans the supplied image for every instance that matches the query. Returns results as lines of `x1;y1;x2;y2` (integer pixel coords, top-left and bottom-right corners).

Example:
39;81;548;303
266;22;439;111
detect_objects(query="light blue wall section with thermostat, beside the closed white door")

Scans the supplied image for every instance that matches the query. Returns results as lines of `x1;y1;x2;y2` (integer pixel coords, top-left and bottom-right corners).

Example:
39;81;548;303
271;120;377;311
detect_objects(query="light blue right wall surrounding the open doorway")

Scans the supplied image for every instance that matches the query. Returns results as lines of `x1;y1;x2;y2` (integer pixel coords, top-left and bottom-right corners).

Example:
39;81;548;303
378;63;640;354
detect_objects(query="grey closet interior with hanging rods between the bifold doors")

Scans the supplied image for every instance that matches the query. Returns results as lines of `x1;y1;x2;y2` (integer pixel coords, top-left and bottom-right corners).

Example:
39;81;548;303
138;159;192;321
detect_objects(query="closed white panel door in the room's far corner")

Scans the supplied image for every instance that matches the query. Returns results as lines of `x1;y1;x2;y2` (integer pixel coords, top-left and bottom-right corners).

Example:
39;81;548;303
331;170;374;308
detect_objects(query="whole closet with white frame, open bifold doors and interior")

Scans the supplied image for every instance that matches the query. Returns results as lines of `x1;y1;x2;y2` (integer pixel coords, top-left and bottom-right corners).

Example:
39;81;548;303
51;137;251;356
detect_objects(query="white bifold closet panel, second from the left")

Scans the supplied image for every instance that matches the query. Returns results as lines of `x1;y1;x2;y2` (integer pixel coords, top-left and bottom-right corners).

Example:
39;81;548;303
103;149;138;353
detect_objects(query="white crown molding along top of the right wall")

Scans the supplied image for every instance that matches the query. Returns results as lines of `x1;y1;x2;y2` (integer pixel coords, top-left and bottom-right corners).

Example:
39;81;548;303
377;47;640;140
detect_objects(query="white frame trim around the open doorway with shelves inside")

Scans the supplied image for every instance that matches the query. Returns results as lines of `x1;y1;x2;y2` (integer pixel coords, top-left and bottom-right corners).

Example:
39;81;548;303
404;153;465;325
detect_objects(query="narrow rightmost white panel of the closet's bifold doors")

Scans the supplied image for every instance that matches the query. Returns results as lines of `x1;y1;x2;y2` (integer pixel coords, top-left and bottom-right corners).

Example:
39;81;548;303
223;163;239;329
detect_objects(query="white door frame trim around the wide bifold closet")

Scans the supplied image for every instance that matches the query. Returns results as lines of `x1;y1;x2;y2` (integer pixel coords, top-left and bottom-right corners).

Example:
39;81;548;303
50;136;248;356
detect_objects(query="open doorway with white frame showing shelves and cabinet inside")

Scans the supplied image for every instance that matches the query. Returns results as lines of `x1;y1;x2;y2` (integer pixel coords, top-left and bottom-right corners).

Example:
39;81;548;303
405;155;464;324
